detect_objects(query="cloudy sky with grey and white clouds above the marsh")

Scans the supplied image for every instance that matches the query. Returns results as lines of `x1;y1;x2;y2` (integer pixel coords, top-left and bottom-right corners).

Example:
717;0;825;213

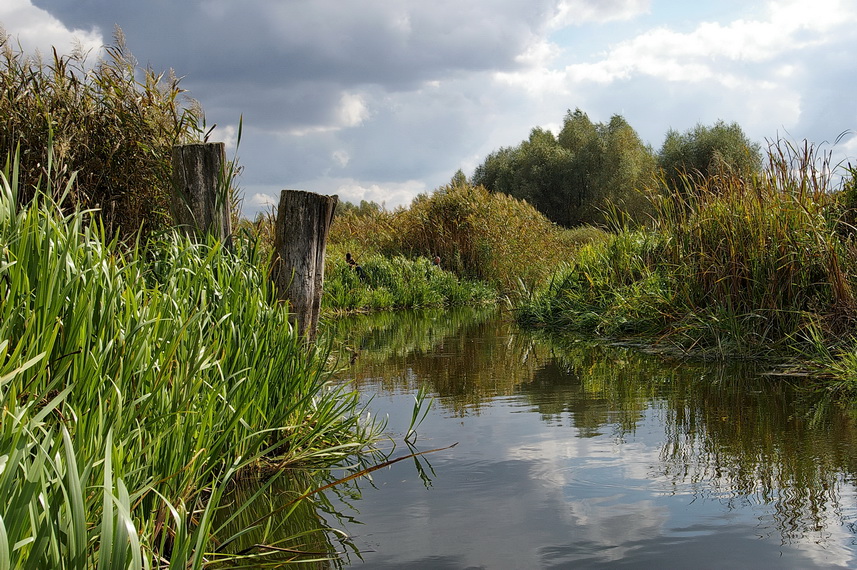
0;0;857;217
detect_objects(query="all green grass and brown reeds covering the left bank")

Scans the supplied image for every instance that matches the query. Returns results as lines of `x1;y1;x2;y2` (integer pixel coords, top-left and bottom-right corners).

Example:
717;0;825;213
0;35;398;569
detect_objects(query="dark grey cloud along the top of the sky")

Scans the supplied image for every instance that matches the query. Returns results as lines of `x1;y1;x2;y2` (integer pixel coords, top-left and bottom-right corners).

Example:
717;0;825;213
35;0;553;88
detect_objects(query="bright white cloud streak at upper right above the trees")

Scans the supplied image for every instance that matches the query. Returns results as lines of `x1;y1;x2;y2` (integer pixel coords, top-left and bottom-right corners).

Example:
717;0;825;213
496;0;857;93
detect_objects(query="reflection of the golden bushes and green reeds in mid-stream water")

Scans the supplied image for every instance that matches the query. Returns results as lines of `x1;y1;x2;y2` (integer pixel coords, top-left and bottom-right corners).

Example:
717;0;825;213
327;308;549;415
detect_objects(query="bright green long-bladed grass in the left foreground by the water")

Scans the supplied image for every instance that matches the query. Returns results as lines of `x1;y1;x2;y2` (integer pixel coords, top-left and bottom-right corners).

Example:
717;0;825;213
0;154;377;568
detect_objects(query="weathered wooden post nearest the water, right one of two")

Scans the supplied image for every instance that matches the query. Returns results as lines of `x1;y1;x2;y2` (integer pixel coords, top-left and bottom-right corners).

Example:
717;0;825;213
271;190;339;340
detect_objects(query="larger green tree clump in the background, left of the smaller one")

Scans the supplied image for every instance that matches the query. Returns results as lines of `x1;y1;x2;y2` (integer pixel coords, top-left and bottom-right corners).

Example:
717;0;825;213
473;109;655;226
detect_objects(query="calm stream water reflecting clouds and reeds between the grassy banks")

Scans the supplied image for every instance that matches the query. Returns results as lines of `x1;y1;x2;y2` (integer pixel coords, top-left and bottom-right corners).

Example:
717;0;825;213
229;311;857;570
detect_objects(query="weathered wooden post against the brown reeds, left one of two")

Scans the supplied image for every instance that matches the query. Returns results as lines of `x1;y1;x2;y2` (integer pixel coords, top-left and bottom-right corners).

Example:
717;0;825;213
172;143;232;243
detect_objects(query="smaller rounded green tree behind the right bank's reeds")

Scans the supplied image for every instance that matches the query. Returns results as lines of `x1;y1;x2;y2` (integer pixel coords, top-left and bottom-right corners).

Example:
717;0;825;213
658;121;762;191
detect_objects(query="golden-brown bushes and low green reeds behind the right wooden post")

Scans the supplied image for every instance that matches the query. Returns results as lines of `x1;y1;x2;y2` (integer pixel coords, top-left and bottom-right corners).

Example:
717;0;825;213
312;176;608;312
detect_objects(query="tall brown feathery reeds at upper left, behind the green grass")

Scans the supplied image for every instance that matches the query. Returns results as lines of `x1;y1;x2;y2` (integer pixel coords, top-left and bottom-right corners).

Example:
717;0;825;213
0;29;204;236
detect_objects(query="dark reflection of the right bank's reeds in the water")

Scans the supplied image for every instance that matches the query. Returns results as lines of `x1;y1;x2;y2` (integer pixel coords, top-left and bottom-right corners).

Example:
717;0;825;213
528;343;857;542
